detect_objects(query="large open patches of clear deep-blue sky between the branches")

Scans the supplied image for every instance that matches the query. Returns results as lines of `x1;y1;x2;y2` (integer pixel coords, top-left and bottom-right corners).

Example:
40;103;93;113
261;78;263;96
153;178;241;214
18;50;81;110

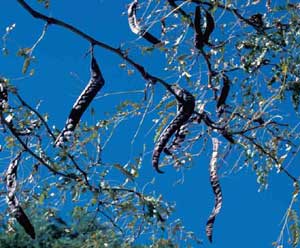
0;0;299;248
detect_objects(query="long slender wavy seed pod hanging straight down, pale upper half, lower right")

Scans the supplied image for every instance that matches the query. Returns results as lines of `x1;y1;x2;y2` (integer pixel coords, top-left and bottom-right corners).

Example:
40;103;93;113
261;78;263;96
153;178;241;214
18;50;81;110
206;138;222;242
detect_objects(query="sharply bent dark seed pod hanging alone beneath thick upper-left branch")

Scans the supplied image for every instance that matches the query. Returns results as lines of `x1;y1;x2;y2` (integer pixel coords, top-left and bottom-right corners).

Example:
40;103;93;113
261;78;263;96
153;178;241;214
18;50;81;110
55;56;104;146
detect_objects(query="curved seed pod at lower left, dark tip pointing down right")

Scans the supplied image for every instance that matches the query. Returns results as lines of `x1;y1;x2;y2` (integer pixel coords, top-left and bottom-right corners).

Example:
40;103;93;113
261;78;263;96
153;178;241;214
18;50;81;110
5;153;35;239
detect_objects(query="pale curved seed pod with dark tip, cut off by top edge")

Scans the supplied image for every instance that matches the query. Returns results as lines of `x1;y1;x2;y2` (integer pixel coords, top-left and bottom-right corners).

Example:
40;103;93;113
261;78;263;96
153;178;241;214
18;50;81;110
127;0;161;45
